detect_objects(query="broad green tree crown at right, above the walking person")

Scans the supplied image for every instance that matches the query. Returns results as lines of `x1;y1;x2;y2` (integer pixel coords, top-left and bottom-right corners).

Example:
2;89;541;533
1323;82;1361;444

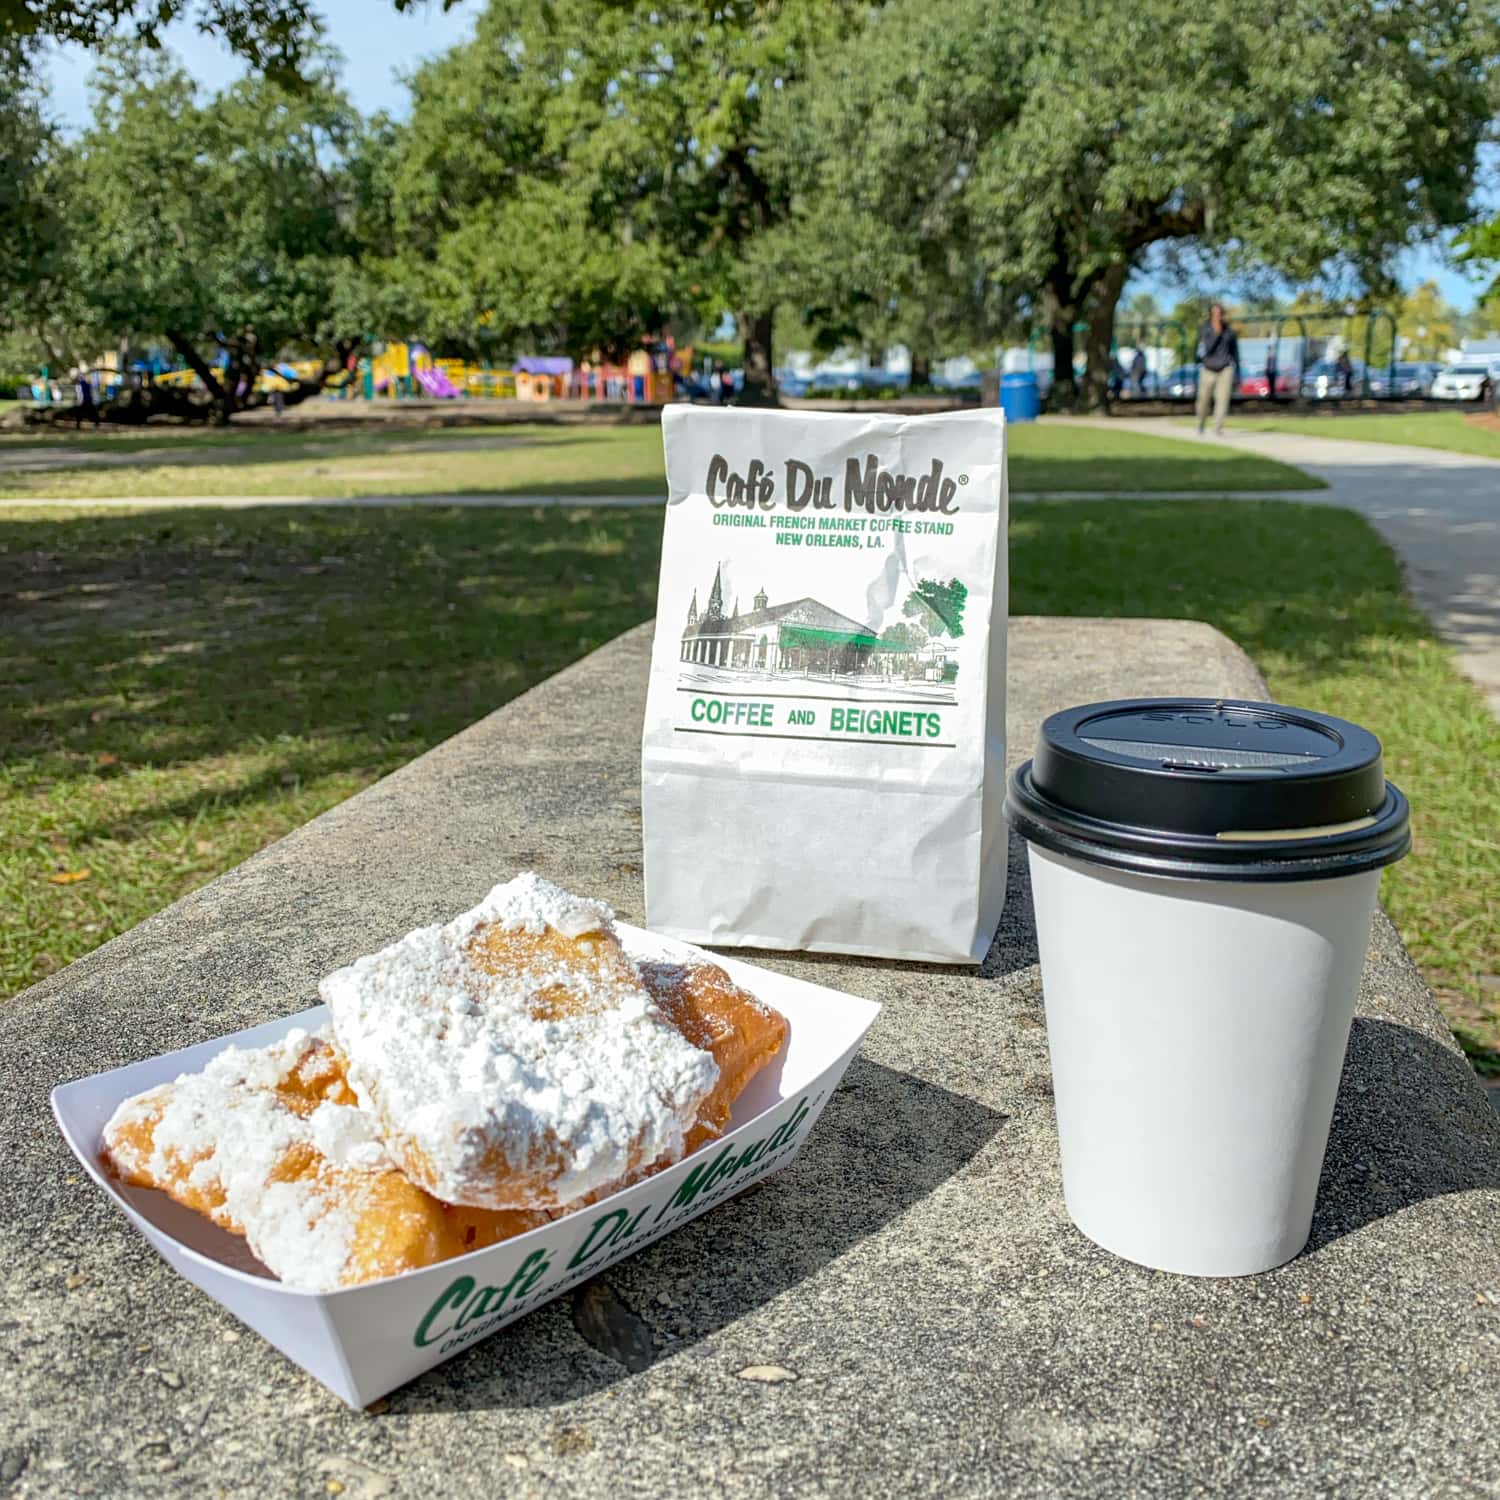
774;0;1500;395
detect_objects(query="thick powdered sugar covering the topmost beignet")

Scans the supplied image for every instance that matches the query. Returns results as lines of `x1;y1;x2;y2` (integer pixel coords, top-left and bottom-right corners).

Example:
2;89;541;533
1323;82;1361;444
321;875;719;1208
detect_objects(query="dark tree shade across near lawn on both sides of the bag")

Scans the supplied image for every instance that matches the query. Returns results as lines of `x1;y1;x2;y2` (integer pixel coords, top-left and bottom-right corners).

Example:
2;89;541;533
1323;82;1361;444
0;501;1452;846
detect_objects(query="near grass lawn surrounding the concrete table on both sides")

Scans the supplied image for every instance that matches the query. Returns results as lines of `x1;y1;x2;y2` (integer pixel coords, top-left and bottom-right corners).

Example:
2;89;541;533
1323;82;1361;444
0;501;1500;1071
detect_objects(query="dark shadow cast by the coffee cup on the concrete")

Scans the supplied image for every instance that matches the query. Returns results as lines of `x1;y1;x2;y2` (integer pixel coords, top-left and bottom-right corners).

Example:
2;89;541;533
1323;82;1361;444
1304;1017;1500;1254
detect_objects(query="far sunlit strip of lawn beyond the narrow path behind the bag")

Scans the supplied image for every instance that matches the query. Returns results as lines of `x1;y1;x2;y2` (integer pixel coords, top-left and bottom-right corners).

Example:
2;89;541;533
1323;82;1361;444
0;423;1322;500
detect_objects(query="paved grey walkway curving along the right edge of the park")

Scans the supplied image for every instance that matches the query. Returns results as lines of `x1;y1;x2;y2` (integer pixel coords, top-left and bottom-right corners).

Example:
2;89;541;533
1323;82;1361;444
1052;417;1500;716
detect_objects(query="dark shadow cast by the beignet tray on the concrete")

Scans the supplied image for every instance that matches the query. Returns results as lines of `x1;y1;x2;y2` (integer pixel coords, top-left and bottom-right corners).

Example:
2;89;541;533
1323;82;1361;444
390;1058;1005;1416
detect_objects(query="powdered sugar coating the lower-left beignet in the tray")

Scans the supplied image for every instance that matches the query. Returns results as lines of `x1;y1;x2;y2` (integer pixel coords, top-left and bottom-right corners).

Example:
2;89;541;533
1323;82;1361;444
104;1029;392;1292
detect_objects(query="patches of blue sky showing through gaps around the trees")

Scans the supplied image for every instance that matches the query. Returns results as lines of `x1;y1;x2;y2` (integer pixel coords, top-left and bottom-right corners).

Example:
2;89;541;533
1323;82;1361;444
35;0;1500;312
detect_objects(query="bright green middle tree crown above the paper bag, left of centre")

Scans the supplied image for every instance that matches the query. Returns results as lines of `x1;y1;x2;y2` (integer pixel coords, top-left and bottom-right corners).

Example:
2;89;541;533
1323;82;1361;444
389;0;864;386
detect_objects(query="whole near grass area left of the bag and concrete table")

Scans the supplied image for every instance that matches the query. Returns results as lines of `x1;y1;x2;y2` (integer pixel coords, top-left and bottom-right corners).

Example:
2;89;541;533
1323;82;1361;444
0;509;662;995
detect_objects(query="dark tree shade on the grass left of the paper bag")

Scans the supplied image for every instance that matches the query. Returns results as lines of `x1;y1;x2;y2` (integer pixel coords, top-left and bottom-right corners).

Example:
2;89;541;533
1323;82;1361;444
0;509;662;837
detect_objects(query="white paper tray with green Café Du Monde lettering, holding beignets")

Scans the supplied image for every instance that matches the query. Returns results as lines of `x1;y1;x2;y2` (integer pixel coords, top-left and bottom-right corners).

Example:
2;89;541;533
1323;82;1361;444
53;923;879;1407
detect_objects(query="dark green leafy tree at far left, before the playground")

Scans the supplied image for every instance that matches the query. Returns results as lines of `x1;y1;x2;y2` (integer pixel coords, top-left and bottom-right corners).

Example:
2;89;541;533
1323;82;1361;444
46;50;384;416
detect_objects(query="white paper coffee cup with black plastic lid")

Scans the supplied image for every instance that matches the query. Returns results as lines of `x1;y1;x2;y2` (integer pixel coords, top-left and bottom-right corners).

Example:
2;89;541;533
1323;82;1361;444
1008;699;1410;1277
